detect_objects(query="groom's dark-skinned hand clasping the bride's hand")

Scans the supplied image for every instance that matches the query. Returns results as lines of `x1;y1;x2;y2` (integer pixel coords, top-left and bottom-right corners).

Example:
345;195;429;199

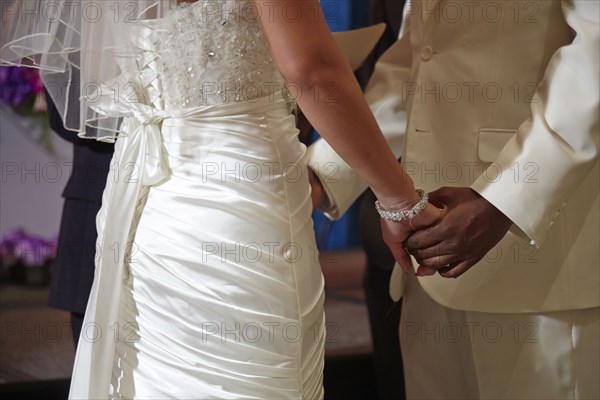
405;187;512;278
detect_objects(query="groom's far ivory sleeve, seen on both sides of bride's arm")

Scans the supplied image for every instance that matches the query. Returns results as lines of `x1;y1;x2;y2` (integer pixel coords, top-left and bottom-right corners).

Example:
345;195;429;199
308;20;412;219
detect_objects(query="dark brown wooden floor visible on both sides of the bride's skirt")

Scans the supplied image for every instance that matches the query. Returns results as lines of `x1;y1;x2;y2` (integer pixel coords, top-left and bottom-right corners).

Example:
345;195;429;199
0;250;374;400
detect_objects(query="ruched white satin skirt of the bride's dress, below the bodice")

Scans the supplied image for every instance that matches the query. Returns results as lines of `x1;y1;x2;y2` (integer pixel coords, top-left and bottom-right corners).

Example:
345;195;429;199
79;99;325;399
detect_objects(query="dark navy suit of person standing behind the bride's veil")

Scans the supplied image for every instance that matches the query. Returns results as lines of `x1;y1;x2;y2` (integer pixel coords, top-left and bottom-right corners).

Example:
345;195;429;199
46;93;114;346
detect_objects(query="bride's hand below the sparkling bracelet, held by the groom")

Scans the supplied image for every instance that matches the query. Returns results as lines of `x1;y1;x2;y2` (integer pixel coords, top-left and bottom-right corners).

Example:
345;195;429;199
381;203;442;276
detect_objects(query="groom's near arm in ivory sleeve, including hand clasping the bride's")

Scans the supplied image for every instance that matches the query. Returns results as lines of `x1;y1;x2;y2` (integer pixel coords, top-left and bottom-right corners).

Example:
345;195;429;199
406;0;600;277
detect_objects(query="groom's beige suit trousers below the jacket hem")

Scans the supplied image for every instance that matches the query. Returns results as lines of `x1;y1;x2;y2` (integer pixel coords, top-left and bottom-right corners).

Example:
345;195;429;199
400;275;600;400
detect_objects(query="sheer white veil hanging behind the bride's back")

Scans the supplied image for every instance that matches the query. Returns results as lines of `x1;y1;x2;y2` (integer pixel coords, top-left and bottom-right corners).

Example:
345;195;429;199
0;0;177;141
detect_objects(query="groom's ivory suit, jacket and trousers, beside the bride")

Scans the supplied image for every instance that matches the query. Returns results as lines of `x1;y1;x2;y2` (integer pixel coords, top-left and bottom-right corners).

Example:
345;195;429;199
309;0;600;397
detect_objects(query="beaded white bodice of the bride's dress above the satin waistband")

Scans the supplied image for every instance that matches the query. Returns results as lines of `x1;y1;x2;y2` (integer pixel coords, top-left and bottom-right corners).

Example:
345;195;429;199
134;0;284;110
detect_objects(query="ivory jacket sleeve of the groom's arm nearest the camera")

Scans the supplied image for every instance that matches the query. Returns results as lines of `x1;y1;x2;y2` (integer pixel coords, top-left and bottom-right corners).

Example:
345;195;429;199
472;0;600;246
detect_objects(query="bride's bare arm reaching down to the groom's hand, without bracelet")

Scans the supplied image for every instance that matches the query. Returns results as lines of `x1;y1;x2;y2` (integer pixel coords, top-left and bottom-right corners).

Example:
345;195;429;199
253;0;439;264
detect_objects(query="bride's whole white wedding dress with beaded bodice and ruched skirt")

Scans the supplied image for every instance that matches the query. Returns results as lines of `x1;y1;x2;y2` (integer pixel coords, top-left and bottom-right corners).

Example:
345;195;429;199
70;0;324;399
